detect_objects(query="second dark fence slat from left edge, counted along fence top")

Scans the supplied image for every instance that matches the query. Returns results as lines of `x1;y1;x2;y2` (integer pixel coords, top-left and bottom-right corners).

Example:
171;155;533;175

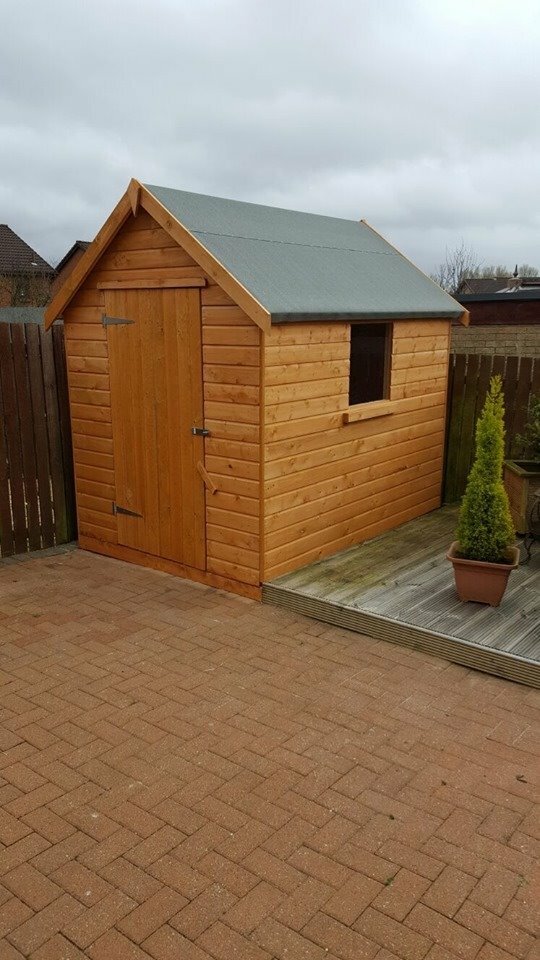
11;324;41;550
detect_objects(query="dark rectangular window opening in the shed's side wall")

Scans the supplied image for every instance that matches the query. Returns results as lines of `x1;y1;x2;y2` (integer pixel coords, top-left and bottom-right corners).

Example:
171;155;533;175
349;323;391;406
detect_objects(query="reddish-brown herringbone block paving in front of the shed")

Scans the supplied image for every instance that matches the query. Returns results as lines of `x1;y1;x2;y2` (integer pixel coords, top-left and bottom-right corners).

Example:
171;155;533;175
0;551;540;960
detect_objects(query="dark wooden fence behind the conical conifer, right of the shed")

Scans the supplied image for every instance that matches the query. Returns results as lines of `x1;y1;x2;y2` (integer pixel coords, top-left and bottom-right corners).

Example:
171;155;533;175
444;353;540;503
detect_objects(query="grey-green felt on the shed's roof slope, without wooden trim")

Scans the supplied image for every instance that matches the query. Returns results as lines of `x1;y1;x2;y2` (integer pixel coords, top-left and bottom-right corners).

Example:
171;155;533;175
146;185;463;323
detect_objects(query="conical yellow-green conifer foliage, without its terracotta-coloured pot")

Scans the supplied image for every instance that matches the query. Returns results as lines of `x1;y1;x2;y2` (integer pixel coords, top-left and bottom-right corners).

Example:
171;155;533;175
457;377;515;563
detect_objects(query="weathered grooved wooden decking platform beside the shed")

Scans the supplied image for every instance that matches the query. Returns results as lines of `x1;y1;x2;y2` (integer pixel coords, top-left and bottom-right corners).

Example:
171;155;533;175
263;507;540;687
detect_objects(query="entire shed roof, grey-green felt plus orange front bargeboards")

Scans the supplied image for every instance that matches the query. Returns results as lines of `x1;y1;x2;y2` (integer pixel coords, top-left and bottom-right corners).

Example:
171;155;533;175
45;180;468;329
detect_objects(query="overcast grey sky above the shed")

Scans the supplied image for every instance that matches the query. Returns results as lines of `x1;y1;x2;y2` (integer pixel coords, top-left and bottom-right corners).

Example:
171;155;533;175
0;0;540;271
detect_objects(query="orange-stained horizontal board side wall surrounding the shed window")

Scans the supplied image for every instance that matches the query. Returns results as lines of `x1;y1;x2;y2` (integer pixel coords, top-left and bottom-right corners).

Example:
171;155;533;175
264;321;449;580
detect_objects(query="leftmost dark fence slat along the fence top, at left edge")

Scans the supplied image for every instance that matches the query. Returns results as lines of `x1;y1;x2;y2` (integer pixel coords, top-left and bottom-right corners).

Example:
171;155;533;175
0;325;28;553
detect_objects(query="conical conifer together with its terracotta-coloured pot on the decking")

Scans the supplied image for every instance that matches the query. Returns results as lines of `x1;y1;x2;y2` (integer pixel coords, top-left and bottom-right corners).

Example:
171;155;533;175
447;377;519;607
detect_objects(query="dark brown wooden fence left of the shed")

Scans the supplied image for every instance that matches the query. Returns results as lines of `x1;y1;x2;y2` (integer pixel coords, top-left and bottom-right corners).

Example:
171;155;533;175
0;311;77;557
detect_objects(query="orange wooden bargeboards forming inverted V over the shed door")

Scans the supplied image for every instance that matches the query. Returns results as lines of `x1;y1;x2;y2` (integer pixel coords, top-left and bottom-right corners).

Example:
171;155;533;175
45;180;271;331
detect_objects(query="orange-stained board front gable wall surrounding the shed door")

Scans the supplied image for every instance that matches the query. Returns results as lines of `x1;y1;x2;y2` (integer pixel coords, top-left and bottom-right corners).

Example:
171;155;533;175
62;211;260;587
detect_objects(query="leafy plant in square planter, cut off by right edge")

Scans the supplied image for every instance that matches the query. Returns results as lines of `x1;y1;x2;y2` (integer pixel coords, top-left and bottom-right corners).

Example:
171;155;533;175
503;397;540;533
